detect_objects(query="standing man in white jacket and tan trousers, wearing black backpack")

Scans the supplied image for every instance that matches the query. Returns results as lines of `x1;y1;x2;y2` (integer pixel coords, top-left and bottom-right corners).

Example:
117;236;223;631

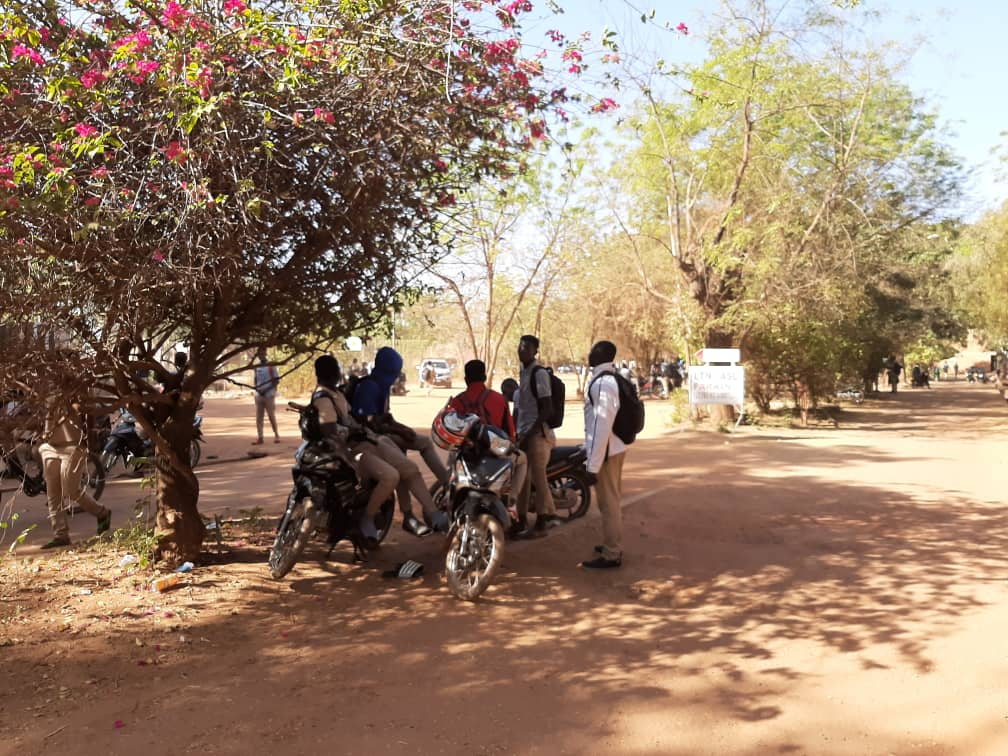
581;342;626;570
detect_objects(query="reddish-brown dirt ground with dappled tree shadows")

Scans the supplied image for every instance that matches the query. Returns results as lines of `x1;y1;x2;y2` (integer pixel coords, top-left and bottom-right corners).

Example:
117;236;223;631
0;383;1008;755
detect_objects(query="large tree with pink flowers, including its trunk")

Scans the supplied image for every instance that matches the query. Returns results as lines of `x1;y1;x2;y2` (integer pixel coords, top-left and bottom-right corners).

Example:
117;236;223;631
0;0;578;560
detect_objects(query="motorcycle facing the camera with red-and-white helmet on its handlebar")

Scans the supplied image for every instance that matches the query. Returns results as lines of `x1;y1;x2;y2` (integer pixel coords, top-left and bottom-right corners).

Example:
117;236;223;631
431;409;515;601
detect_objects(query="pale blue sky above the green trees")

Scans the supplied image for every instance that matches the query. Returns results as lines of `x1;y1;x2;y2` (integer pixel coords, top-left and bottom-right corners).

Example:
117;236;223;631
548;0;1008;220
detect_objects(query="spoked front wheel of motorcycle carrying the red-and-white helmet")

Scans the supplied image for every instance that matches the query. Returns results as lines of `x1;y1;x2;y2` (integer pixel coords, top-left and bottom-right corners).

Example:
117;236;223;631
445;514;504;601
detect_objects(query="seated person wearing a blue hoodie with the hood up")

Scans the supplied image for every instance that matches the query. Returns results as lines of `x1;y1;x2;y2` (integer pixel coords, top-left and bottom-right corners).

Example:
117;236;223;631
350;347;449;535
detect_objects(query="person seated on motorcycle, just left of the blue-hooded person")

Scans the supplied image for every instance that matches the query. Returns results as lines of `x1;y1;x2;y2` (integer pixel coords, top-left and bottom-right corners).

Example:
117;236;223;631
311;355;399;540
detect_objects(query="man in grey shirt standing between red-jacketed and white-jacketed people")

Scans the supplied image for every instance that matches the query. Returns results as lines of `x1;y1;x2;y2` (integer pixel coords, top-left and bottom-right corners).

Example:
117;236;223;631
510;335;556;538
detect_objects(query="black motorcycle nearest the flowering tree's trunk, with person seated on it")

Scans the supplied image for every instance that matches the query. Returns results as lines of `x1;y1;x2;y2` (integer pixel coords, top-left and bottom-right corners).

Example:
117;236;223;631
269;401;395;580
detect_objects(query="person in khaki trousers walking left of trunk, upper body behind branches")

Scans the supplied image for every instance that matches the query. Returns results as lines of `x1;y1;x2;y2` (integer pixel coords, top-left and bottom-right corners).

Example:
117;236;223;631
38;403;112;548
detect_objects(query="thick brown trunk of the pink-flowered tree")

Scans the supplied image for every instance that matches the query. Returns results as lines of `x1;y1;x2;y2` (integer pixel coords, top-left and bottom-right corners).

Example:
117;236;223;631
155;404;207;564
